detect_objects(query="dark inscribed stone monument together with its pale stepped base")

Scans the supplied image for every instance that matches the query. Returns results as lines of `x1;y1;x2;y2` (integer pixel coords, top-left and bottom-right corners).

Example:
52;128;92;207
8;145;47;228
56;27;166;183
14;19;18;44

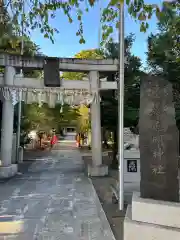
124;76;180;240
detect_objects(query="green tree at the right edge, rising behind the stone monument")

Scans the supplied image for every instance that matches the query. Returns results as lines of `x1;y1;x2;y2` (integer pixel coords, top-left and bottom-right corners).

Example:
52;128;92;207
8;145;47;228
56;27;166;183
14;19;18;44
147;3;180;147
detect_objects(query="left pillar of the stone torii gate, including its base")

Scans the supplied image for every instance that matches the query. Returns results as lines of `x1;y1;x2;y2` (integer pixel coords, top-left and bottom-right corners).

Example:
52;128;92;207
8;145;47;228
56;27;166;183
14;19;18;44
0;66;17;179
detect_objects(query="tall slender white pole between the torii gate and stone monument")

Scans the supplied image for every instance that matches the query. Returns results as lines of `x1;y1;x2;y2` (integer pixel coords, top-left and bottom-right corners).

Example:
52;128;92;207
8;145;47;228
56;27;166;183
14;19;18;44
118;4;124;211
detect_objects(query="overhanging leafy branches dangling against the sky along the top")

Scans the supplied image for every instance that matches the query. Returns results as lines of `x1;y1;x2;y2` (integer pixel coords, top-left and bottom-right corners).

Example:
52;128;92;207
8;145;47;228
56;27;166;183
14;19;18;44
4;0;179;43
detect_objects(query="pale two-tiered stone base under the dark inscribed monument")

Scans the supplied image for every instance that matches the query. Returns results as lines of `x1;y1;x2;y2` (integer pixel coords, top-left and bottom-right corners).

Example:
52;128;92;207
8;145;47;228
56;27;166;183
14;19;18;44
124;193;180;240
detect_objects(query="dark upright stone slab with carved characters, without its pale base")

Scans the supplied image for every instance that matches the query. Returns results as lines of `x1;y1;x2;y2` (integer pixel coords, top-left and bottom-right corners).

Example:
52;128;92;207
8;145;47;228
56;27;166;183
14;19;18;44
139;77;179;202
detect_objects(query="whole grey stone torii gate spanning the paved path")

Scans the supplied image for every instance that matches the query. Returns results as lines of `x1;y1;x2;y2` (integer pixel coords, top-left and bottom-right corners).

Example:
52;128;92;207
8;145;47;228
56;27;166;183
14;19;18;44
0;54;118;178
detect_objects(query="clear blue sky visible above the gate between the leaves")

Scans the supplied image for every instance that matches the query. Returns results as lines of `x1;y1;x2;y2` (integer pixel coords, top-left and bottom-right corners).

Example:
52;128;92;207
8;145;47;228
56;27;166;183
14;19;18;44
32;0;160;64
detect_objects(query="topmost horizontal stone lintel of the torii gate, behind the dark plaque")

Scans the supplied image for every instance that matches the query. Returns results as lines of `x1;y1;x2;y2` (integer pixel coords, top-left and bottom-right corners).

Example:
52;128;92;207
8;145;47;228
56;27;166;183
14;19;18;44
0;53;127;72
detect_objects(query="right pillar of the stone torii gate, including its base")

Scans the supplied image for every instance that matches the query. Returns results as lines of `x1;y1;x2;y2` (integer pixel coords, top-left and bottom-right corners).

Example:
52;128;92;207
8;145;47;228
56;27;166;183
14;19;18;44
87;71;108;177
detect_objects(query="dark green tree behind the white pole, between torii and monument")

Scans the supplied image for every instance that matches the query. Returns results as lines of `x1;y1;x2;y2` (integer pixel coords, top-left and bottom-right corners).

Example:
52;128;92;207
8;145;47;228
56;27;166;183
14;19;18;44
101;34;142;167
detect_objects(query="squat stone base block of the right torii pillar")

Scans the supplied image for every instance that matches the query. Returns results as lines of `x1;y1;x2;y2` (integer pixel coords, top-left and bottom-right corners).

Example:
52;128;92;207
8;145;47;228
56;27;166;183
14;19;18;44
85;164;108;177
